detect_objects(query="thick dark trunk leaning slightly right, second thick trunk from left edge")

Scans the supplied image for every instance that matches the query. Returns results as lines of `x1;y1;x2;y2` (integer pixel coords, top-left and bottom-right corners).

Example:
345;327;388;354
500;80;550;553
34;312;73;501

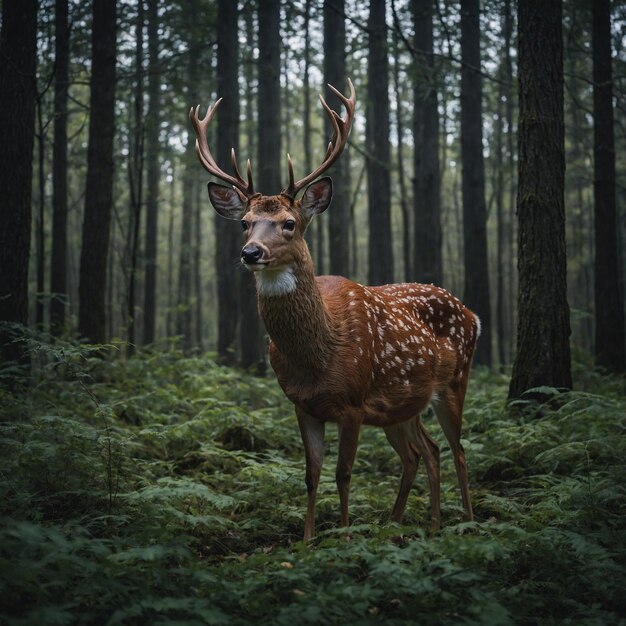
78;0;116;343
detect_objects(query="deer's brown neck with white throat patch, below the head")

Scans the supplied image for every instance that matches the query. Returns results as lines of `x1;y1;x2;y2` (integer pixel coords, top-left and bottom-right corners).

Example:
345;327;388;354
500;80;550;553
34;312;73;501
256;251;336;374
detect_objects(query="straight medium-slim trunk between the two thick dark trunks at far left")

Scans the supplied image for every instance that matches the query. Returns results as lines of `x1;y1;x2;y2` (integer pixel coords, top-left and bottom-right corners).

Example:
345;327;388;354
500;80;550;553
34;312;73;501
50;0;70;335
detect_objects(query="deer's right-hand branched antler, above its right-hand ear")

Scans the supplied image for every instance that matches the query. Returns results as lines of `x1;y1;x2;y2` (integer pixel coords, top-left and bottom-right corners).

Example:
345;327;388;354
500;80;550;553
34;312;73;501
281;79;356;198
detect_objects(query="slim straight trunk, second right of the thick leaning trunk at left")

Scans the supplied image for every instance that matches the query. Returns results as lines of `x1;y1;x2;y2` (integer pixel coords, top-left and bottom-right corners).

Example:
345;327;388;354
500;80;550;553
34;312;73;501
143;0;161;344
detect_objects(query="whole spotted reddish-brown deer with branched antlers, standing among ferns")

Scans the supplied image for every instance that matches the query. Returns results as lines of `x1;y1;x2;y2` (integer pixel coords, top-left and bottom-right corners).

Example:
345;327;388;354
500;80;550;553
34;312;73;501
189;79;480;541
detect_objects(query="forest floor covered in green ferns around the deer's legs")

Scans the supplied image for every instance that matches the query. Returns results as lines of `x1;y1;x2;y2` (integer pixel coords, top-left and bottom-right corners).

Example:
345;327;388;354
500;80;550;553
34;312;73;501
0;340;626;626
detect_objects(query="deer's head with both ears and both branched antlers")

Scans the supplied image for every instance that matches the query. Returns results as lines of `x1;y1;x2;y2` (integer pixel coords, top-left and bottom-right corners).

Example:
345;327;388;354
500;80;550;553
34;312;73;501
189;79;356;280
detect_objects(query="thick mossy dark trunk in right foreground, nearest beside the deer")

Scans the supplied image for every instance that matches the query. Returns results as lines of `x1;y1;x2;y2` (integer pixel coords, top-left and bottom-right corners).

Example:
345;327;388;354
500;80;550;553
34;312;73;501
509;0;572;398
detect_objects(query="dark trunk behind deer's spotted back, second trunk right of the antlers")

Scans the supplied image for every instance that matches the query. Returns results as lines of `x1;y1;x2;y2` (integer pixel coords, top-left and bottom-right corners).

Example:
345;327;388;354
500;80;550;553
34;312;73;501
411;0;443;285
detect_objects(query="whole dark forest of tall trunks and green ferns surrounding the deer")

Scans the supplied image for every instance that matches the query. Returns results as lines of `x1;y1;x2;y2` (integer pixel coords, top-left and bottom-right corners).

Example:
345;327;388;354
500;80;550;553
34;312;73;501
0;0;626;625
